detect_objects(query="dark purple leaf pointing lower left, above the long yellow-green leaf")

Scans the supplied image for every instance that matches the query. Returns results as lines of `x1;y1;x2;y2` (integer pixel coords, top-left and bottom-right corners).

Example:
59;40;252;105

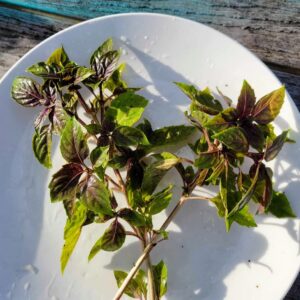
49;163;84;202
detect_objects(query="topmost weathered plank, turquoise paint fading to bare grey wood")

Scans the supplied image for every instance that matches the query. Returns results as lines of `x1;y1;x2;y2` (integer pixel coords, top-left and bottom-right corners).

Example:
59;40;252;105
0;0;300;69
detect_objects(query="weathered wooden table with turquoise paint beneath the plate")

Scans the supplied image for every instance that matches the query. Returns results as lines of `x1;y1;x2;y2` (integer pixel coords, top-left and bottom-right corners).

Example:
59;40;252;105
0;0;300;300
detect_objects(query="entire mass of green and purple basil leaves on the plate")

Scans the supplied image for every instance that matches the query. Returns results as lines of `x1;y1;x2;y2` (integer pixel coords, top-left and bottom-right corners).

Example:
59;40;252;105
11;39;295;299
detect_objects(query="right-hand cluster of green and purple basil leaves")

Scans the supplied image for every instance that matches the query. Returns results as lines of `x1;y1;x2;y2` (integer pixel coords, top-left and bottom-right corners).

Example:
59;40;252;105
176;81;295;230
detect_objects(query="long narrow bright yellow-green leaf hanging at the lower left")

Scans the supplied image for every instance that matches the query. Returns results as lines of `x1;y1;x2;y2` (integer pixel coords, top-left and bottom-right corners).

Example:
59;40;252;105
60;202;87;273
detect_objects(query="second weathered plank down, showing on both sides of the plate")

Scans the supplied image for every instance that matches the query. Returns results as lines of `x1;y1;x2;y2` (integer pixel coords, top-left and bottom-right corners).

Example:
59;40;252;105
0;7;300;108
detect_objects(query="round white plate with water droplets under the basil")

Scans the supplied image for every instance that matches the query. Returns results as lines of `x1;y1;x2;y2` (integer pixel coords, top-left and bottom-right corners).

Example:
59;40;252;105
0;14;300;300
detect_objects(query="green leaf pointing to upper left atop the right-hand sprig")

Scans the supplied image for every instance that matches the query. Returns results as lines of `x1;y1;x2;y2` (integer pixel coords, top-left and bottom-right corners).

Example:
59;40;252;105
175;82;223;115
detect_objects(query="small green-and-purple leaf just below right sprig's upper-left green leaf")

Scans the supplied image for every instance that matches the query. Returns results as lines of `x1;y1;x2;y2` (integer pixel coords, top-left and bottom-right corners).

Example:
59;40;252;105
204;107;237;132
